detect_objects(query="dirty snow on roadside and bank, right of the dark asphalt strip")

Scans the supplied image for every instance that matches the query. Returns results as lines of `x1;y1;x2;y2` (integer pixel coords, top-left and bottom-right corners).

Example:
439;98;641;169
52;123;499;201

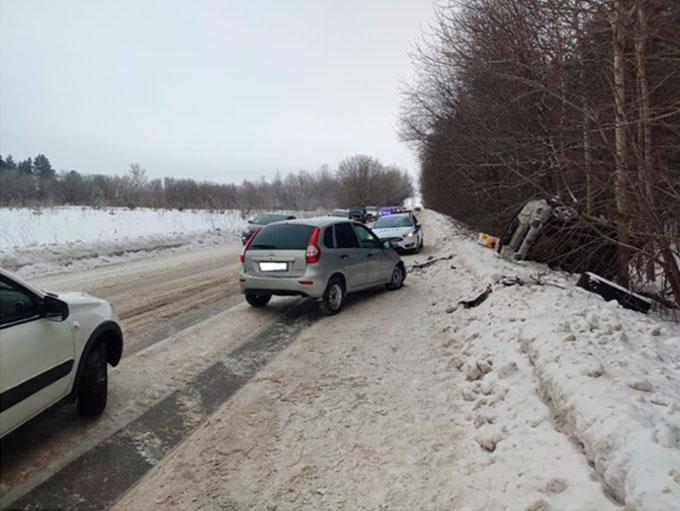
117;212;680;511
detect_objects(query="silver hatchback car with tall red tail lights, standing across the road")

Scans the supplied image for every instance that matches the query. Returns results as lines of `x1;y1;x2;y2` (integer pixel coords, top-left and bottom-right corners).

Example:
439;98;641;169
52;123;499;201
239;217;406;315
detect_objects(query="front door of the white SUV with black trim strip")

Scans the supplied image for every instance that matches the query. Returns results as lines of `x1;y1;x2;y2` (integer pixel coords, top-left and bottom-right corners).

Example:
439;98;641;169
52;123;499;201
0;277;75;436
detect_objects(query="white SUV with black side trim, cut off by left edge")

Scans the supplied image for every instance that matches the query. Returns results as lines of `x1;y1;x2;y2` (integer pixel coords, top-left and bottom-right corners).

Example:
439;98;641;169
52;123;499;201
0;269;123;437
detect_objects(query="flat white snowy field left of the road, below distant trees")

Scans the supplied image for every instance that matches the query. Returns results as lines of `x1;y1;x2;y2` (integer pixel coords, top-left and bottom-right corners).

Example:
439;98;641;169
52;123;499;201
0;206;250;277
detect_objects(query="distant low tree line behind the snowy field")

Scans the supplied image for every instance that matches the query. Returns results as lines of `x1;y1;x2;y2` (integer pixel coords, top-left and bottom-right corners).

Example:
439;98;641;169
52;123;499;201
0;154;414;214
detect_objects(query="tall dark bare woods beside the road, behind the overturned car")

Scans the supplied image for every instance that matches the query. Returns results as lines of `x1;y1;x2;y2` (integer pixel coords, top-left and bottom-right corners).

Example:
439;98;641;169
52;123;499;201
400;0;680;305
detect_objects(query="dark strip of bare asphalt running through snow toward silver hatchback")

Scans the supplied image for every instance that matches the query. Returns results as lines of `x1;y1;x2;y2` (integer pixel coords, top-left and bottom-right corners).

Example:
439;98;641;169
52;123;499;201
7;300;317;509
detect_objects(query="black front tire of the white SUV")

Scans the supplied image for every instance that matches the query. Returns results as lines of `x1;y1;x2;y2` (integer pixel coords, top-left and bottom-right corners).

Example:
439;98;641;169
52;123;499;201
78;341;108;416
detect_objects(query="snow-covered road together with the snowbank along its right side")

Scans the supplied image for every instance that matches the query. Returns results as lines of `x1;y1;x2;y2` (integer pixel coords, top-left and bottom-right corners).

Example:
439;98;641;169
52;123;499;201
0;212;680;511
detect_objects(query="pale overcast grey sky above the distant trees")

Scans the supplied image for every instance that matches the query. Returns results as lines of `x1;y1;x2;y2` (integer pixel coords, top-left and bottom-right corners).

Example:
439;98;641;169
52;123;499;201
0;0;433;182
